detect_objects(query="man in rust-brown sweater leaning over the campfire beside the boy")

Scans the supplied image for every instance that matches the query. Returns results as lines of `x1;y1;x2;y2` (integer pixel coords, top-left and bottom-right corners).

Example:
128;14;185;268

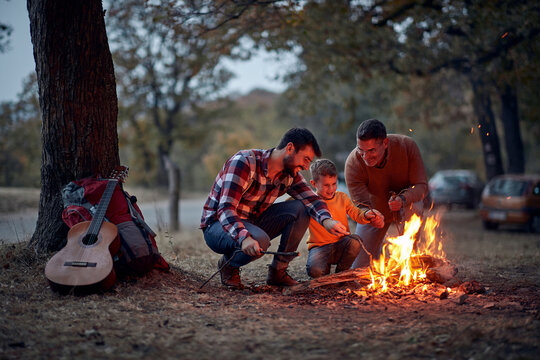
345;119;428;268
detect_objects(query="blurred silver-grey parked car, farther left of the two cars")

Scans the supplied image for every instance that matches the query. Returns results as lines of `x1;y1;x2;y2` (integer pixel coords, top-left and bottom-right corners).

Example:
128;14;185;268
429;169;484;209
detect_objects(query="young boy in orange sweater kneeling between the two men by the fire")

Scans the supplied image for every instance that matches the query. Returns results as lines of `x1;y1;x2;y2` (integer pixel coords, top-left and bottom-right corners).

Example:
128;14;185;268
306;159;384;278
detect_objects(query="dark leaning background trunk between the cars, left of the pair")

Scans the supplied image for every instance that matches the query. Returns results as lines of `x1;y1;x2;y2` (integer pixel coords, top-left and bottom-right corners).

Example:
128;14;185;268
469;74;504;180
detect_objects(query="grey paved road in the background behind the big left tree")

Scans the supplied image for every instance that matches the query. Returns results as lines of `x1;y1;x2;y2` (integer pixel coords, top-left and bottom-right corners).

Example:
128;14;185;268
0;199;206;243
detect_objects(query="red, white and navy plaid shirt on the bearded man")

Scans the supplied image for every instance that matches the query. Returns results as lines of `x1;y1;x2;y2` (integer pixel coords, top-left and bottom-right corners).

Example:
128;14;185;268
201;149;331;243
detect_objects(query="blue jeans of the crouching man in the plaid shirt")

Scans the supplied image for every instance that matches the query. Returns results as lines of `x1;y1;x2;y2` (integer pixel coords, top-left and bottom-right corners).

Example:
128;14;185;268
203;200;309;269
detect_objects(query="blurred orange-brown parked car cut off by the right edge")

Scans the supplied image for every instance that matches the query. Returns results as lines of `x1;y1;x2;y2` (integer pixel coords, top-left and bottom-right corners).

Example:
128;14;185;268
480;174;540;232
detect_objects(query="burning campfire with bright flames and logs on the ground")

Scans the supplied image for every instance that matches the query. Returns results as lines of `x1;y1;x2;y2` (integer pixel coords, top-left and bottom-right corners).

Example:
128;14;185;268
287;213;457;298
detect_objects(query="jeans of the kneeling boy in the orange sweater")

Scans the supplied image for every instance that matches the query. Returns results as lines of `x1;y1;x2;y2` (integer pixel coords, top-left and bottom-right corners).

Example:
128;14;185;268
306;234;362;278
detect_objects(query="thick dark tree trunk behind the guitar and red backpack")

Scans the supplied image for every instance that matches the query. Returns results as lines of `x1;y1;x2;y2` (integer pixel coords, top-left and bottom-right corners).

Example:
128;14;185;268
27;0;120;251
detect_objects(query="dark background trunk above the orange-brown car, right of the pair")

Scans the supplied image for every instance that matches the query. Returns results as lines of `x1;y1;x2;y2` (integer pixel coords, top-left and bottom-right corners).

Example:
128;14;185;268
499;84;525;174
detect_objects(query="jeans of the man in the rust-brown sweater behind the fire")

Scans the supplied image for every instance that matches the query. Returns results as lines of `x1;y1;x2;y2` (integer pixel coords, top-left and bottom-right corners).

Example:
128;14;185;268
352;201;423;269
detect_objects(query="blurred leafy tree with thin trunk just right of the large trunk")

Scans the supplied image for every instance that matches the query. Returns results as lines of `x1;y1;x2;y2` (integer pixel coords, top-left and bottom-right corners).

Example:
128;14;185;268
105;0;237;230
